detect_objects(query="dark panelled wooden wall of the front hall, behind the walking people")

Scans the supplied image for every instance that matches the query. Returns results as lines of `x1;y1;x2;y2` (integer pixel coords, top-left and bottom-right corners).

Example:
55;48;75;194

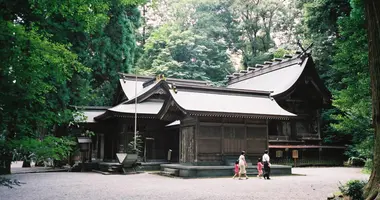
180;115;268;164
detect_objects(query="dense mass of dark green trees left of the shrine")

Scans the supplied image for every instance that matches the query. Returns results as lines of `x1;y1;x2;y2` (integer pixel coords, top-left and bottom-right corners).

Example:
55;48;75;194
0;0;145;173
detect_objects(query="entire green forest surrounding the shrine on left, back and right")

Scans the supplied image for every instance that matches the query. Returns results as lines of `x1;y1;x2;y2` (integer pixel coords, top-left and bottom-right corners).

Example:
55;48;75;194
0;0;374;173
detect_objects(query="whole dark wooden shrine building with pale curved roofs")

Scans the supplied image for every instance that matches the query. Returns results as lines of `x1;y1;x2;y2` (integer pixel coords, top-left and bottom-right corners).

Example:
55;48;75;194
83;53;344;165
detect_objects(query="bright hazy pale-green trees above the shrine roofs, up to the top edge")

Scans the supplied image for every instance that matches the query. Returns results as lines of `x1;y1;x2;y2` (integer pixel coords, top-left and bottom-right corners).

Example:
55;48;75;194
137;0;299;81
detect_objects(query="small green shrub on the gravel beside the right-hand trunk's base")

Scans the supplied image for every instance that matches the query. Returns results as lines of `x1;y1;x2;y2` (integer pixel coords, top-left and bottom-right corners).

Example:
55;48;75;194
339;180;366;200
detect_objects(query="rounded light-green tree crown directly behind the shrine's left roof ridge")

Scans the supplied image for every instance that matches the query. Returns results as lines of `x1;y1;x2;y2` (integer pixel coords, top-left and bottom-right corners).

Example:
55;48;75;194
137;25;232;82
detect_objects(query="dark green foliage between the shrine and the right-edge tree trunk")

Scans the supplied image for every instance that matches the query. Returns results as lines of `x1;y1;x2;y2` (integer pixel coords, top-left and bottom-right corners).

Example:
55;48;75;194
332;1;373;158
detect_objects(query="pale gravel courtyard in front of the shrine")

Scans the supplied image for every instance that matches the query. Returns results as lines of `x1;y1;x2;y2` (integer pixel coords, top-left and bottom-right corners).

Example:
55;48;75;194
0;168;368;200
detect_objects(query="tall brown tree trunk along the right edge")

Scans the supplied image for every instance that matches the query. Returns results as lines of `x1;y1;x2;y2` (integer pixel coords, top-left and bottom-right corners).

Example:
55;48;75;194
364;0;380;200
